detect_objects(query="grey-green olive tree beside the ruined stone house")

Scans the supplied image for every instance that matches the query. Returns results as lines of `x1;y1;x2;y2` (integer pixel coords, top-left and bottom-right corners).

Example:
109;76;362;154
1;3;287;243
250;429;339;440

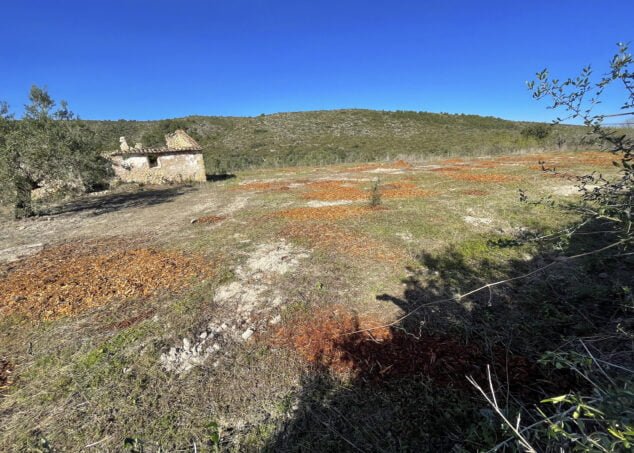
0;86;109;218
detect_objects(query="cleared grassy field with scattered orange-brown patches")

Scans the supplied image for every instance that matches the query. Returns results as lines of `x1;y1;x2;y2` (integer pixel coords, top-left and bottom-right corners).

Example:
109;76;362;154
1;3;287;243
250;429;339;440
0;152;632;451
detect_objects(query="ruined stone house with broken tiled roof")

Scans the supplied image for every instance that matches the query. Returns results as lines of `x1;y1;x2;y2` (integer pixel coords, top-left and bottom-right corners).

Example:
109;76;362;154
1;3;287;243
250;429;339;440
109;129;207;184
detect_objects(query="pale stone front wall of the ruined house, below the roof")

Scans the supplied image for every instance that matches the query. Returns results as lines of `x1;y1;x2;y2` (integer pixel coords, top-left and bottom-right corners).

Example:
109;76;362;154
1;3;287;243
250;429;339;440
112;152;206;184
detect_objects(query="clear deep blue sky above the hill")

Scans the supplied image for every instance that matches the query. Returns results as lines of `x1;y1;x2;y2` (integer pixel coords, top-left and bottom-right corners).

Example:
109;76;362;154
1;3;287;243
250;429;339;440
0;0;634;120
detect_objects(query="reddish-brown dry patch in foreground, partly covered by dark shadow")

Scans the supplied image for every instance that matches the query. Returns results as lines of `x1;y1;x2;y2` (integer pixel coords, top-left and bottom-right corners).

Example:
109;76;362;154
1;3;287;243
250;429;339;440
270;306;539;389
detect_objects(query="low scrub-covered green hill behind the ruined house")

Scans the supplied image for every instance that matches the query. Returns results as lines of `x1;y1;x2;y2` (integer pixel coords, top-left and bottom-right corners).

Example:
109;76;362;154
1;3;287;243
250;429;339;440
85;110;587;172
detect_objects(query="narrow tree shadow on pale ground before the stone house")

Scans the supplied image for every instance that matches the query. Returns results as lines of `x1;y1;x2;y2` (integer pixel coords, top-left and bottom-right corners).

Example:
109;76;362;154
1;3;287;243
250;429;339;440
40;186;196;216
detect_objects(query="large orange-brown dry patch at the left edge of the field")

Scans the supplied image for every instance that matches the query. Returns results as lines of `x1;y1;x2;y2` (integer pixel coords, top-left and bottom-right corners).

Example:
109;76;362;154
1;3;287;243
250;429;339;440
0;241;211;319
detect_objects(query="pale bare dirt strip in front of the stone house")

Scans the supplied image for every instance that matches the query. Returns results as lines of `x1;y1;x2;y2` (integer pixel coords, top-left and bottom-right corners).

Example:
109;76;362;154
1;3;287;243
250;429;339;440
0;186;247;263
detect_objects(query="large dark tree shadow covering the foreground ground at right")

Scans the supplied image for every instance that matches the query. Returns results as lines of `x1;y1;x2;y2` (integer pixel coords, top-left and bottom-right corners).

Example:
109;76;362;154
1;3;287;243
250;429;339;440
266;221;634;451
